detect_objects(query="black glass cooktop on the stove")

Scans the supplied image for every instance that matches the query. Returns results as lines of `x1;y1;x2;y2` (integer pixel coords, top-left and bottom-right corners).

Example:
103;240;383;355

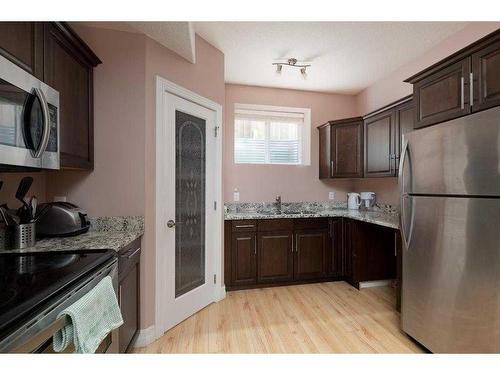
0;250;116;338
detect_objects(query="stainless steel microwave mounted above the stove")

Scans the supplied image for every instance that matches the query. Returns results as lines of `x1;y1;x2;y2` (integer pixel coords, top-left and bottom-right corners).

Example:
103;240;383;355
0;56;59;169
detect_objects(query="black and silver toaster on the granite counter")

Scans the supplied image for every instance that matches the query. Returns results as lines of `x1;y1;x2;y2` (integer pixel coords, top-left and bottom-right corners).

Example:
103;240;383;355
36;202;90;237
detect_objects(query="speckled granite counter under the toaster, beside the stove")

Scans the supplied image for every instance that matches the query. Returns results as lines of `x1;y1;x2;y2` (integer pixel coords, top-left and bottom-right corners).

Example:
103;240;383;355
0;216;144;253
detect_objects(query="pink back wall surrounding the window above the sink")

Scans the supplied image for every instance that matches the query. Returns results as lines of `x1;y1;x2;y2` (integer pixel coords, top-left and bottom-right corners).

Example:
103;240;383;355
224;84;356;202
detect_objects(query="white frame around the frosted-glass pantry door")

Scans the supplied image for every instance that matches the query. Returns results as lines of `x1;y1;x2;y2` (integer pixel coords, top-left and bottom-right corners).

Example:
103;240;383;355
155;75;226;338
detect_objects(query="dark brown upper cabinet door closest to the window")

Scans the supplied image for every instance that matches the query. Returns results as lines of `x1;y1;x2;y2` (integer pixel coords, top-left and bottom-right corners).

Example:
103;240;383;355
331;121;363;177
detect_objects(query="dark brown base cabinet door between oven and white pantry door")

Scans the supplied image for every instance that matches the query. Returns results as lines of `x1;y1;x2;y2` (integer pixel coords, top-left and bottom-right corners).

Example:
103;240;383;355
118;263;139;353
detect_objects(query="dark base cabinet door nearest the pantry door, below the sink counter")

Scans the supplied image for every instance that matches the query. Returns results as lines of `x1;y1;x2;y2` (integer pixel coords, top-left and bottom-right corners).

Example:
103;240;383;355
231;232;257;286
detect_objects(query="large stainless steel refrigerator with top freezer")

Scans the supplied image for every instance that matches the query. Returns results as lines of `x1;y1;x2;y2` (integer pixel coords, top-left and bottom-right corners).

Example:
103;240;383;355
399;108;500;353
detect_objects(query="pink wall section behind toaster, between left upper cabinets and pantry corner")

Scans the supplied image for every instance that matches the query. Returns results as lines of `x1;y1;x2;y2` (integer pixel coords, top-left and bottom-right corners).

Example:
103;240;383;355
47;26;146;216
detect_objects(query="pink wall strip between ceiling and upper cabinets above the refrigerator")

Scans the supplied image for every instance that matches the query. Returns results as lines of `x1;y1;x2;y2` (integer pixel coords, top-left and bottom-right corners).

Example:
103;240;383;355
356;22;500;115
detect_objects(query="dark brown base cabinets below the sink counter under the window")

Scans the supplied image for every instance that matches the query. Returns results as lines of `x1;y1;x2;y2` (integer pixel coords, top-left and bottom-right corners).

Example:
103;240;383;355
224;218;341;290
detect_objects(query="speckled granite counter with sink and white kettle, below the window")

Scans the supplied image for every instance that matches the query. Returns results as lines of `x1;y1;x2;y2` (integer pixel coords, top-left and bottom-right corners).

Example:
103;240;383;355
224;202;399;229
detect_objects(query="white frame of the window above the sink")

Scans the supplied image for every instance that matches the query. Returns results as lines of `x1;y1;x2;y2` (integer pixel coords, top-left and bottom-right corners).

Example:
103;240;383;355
232;103;311;167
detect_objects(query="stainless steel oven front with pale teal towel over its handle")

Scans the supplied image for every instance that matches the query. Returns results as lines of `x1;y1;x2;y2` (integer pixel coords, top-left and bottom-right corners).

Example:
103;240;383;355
0;257;119;353
